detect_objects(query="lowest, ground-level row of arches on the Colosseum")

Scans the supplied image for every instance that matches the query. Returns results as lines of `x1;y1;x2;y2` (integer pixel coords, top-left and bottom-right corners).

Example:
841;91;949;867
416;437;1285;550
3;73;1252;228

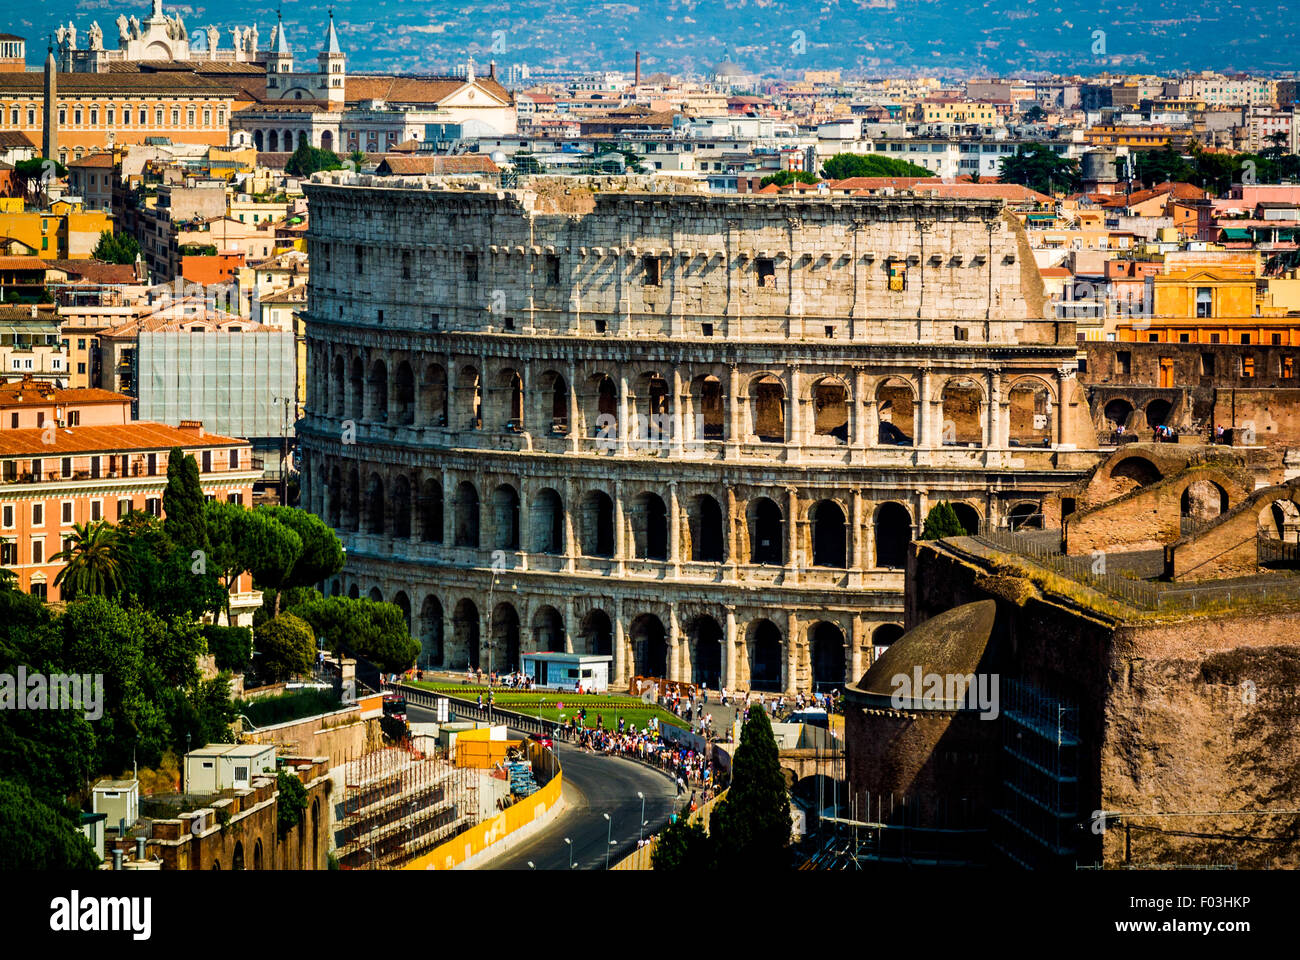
333;580;902;691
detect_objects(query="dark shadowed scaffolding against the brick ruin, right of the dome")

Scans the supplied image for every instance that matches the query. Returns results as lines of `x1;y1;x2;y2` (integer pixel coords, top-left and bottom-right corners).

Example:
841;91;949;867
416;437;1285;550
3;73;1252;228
993;679;1079;870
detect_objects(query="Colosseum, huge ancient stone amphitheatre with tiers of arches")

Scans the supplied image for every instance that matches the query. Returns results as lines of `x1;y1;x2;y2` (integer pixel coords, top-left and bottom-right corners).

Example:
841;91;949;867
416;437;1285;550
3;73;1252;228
299;173;1097;691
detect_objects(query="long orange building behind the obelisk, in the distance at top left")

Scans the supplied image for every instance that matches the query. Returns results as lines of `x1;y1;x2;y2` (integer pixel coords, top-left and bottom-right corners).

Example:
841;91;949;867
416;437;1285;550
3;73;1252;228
0;70;237;165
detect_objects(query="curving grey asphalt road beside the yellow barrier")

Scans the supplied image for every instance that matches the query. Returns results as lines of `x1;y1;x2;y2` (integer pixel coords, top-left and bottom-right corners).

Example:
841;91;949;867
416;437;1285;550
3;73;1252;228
484;744;689;870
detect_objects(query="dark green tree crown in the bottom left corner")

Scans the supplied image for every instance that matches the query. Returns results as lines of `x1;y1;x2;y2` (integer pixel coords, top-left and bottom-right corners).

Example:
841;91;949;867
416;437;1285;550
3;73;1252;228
0;779;99;872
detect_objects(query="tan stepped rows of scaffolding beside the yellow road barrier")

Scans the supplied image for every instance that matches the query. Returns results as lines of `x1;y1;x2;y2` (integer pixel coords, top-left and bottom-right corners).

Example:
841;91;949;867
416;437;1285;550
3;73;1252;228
335;740;478;870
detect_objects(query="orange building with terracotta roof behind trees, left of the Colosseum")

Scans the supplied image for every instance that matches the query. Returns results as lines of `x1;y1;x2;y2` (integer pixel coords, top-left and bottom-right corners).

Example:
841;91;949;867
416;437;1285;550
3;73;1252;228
0;421;261;608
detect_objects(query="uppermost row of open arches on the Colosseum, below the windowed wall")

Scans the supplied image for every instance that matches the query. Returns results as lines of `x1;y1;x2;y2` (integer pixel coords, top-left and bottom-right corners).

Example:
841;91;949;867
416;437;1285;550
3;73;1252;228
313;354;1054;446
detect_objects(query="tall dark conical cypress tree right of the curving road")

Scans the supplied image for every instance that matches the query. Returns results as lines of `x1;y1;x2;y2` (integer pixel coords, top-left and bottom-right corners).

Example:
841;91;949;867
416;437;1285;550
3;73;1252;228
709;708;792;873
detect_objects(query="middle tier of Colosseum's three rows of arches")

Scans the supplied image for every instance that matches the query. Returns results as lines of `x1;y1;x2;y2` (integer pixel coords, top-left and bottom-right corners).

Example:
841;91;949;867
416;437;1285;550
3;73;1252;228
320;463;925;568
